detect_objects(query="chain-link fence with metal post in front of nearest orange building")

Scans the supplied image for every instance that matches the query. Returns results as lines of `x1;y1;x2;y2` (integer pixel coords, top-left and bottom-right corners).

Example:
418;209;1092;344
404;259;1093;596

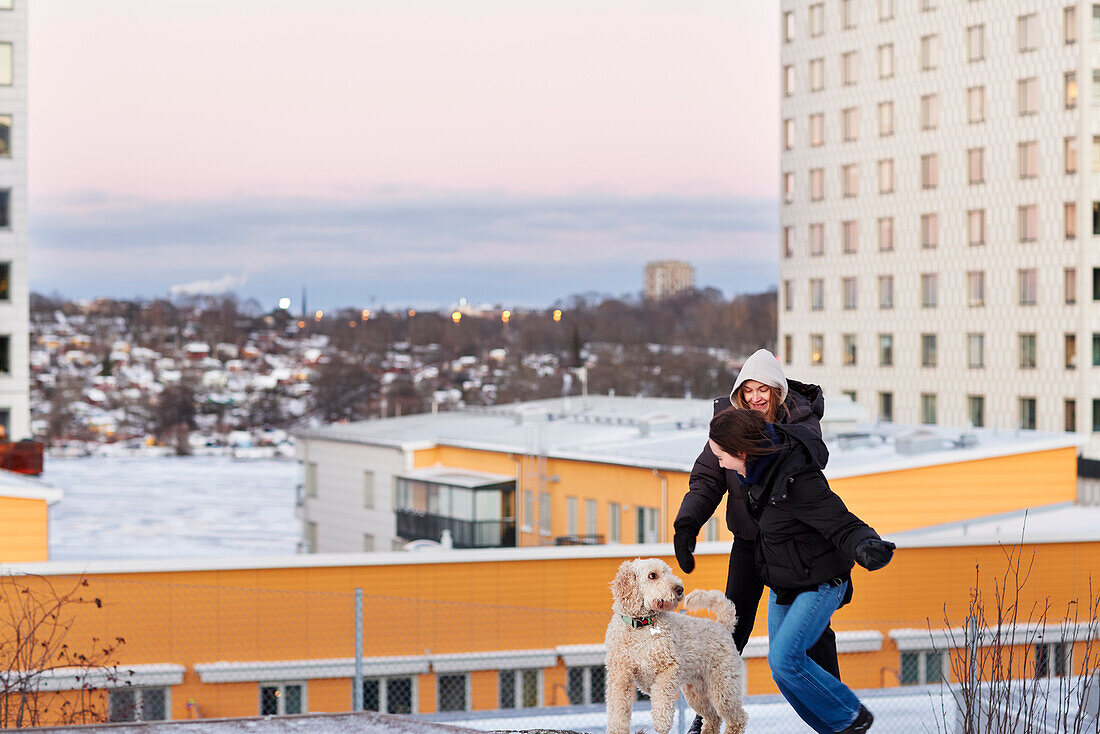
0;566;1100;733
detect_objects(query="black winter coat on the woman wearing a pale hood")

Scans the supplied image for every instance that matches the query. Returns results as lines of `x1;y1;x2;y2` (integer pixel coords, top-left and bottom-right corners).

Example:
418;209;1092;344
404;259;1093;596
673;380;828;540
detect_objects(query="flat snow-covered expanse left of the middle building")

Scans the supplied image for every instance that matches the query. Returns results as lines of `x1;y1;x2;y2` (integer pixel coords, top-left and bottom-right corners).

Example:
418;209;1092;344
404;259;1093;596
42;456;300;560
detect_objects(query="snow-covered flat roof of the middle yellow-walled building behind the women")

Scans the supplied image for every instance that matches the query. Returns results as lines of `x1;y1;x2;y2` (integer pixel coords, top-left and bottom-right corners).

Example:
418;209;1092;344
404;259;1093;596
295;395;1084;479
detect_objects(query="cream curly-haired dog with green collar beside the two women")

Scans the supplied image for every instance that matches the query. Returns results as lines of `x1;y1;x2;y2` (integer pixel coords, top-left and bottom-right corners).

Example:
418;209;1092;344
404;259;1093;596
605;558;749;734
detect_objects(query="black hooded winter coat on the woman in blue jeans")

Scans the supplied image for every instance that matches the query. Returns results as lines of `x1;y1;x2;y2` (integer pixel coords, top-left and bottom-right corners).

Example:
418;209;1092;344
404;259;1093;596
743;425;879;593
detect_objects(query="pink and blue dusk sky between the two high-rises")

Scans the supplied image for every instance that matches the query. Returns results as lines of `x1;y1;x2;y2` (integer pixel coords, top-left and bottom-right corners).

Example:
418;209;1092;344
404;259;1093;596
29;0;779;308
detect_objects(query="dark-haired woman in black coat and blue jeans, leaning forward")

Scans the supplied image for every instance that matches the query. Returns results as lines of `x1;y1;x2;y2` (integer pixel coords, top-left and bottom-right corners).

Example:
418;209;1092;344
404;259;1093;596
708;408;894;734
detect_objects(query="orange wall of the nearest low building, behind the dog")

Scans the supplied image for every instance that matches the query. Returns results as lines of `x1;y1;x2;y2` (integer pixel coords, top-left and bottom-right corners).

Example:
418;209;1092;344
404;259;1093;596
0;543;1100;719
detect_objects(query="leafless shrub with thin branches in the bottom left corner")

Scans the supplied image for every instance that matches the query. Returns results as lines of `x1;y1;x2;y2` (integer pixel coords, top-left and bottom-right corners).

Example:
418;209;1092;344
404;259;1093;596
0;574;125;728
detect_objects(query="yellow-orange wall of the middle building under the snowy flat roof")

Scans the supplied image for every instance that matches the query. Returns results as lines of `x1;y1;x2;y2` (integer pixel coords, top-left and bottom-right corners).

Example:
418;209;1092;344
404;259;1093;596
414;446;1077;546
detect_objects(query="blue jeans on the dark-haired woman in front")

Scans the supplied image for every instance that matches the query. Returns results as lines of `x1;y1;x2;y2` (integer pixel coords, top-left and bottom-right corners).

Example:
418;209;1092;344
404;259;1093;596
768;582;859;734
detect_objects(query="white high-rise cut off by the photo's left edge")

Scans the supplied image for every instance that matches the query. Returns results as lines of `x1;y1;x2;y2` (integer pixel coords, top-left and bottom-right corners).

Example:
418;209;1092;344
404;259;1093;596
0;0;30;439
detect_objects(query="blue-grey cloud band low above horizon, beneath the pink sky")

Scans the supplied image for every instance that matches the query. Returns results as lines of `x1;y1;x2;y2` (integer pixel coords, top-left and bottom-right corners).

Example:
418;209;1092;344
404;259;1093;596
31;191;778;307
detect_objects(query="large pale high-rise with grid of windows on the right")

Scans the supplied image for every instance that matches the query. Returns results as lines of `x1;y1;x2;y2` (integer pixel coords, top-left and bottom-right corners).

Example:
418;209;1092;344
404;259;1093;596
778;0;1100;459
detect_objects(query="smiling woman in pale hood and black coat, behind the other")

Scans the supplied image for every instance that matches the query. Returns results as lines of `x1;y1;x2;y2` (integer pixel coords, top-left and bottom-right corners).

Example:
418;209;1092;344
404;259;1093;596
673;349;840;734
